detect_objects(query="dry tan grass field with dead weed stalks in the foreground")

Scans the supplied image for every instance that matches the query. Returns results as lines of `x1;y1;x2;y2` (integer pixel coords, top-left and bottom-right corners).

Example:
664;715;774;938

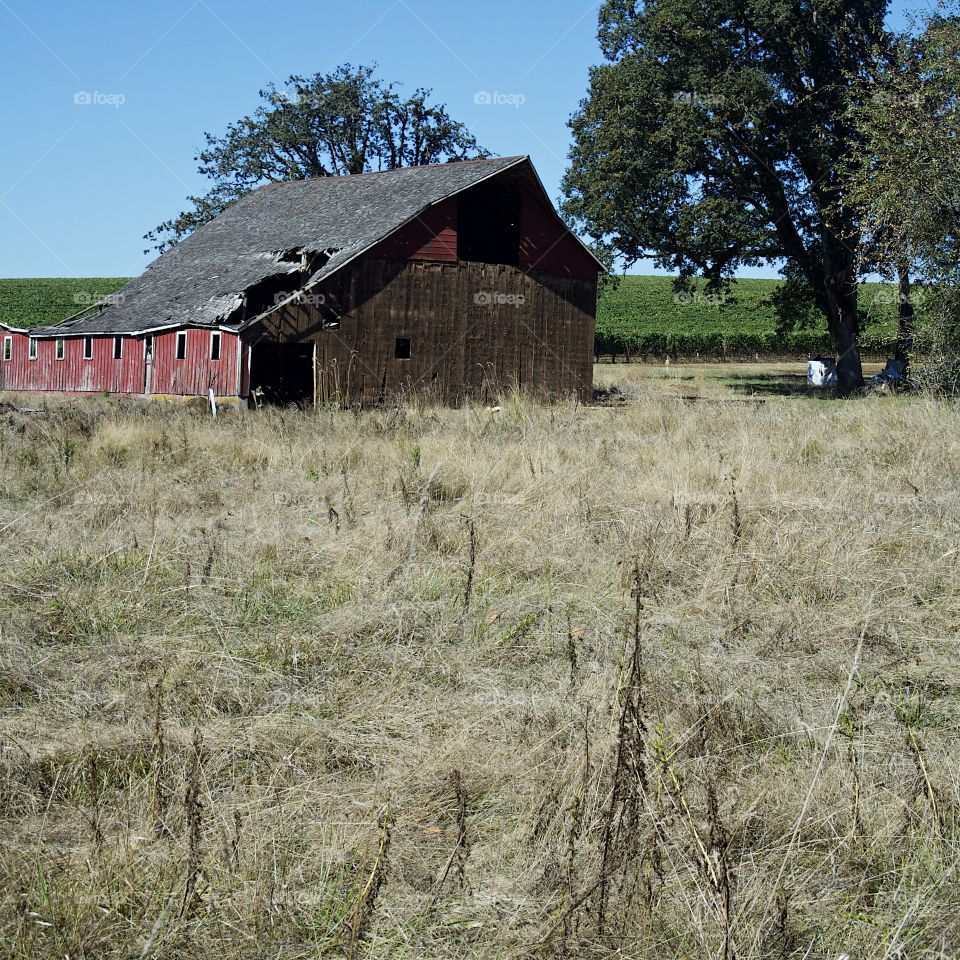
0;366;960;960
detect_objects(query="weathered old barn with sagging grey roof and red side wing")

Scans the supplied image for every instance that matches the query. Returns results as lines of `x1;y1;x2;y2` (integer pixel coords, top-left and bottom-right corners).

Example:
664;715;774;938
0;157;602;403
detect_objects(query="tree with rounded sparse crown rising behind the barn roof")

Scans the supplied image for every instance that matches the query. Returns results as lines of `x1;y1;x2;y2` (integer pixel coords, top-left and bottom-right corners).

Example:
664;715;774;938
144;64;488;253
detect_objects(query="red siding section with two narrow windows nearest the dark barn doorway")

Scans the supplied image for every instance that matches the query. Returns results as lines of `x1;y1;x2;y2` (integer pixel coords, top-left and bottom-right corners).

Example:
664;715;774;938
151;330;239;397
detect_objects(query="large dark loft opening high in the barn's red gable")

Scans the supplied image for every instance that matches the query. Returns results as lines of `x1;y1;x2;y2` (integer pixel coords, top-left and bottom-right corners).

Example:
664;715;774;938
457;184;521;267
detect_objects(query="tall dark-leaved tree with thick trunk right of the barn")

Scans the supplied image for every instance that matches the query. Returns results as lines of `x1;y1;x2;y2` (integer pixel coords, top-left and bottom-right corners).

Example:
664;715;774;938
564;0;887;394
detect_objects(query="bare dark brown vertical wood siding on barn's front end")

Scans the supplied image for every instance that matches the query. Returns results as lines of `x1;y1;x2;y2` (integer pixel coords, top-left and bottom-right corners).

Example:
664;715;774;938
251;259;596;404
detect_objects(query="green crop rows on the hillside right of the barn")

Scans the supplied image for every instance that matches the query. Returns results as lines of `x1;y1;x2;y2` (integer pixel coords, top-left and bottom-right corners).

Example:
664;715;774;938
596;276;897;359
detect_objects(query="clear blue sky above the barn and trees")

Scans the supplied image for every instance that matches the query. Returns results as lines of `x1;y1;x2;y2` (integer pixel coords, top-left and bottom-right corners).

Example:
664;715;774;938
0;0;906;277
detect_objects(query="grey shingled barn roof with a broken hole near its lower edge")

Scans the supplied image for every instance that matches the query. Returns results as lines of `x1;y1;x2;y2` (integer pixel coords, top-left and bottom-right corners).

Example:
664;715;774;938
33;157;592;337
